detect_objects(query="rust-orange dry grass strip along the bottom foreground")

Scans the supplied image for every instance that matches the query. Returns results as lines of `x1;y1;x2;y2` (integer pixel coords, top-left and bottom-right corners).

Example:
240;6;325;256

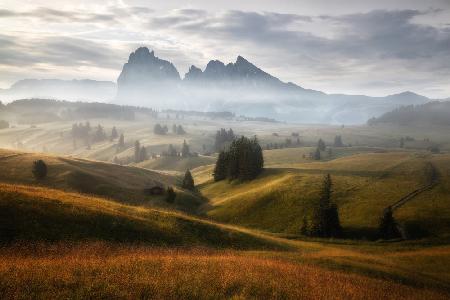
0;244;446;299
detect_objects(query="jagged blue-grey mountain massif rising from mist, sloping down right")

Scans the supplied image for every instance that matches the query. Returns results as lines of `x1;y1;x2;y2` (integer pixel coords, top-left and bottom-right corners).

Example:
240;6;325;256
116;47;429;124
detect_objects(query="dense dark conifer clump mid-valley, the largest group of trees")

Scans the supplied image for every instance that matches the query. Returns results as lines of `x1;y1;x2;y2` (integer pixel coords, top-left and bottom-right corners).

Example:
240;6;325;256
214;136;264;181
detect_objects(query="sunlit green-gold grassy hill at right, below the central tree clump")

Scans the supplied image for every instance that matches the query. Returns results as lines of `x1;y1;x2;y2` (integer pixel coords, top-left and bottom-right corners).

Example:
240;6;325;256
198;152;450;238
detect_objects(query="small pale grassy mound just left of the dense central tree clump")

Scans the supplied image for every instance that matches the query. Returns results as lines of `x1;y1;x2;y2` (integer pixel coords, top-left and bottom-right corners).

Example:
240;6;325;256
136;156;216;172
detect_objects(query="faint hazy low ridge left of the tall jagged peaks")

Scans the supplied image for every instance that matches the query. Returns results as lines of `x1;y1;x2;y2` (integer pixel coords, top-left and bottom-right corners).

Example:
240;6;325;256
0;79;117;101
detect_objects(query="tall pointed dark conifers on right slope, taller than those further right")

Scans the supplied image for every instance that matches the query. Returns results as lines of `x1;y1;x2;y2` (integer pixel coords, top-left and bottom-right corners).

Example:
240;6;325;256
301;174;342;237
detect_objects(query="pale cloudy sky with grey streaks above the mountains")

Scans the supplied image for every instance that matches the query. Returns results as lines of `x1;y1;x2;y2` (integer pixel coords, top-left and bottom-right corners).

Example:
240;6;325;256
0;0;450;98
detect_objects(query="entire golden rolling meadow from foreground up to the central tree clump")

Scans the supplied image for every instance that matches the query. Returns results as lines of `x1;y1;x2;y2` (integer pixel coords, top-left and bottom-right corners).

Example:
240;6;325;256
0;140;450;299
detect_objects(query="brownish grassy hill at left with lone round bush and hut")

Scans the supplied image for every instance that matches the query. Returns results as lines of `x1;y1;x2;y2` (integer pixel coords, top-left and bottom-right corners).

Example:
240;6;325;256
0;149;201;211
